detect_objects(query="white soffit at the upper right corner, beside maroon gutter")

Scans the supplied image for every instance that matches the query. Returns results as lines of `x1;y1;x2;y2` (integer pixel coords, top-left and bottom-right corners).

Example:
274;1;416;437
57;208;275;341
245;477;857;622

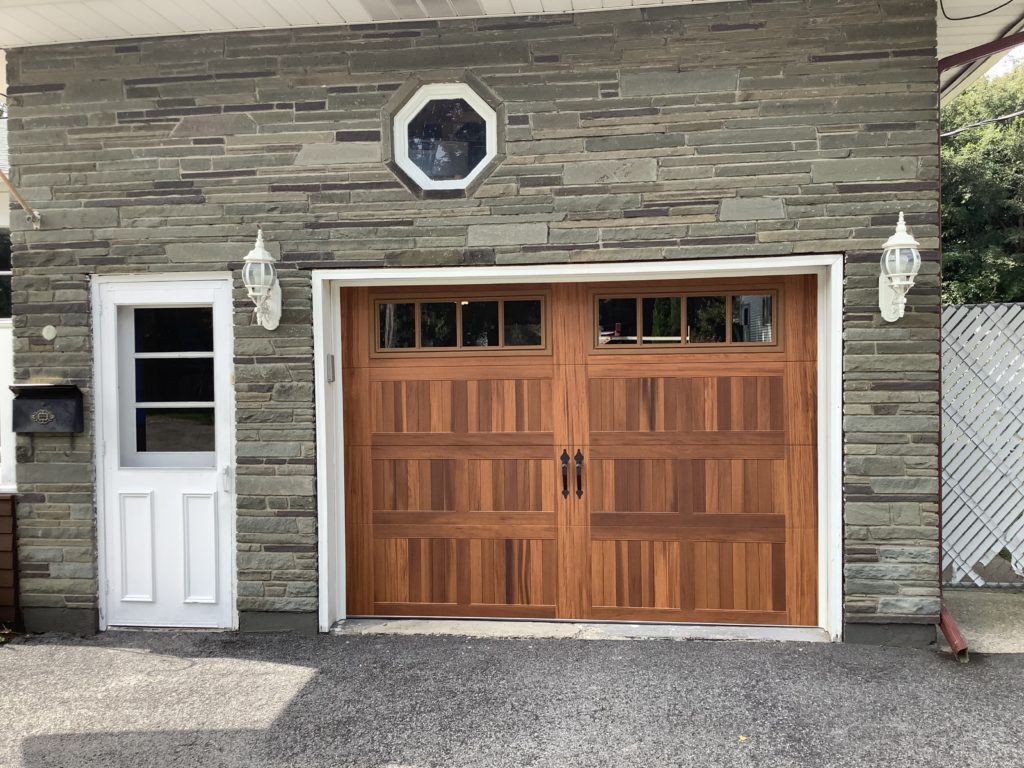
937;0;1024;102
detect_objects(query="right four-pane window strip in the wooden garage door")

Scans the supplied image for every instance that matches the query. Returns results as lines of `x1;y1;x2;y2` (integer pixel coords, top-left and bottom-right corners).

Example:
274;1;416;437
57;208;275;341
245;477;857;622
594;291;778;351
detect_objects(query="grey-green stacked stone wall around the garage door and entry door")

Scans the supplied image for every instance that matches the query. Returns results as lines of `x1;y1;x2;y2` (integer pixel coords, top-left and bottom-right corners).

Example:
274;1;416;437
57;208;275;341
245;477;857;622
9;0;939;627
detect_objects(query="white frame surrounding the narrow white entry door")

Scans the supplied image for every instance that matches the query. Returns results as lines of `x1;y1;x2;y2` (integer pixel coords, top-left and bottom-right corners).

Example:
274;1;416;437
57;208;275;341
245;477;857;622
90;272;239;631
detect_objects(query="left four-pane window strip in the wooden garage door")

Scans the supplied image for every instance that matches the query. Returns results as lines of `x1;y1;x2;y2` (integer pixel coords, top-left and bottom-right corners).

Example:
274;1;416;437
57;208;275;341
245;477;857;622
374;297;546;353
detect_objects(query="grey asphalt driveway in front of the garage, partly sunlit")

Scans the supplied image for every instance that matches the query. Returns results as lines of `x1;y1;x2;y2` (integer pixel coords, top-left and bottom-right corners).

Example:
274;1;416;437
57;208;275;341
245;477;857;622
0;633;1024;768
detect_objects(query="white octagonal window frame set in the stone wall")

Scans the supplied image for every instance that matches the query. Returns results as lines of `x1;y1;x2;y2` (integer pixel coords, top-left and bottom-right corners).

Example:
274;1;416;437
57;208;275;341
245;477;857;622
393;83;498;189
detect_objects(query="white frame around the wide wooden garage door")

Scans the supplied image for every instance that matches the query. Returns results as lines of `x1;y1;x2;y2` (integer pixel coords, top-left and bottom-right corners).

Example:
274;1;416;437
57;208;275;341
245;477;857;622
312;254;843;641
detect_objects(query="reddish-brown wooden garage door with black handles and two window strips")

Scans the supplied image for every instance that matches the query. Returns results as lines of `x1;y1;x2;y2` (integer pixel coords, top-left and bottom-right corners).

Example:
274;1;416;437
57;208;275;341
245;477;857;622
342;276;817;626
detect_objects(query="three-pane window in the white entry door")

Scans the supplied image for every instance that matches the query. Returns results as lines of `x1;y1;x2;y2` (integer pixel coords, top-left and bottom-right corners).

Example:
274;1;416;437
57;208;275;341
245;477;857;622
118;306;217;467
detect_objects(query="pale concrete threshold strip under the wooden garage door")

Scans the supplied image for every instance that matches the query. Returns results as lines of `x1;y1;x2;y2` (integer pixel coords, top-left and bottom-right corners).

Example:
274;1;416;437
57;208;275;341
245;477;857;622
331;617;830;643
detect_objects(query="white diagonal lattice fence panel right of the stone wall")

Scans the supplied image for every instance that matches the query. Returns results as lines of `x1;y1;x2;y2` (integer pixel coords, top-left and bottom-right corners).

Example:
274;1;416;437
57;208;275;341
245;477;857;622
942;304;1024;587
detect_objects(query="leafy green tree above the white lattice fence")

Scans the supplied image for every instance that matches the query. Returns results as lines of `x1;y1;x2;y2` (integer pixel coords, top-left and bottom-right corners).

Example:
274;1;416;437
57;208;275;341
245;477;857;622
941;68;1024;303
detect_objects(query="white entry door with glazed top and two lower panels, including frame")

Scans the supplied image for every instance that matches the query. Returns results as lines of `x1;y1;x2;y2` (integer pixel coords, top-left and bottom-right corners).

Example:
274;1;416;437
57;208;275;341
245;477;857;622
96;280;236;628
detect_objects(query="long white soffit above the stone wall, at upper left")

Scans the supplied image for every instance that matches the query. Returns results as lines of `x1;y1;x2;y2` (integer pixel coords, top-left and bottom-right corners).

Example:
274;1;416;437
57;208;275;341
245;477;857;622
0;0;737;48
